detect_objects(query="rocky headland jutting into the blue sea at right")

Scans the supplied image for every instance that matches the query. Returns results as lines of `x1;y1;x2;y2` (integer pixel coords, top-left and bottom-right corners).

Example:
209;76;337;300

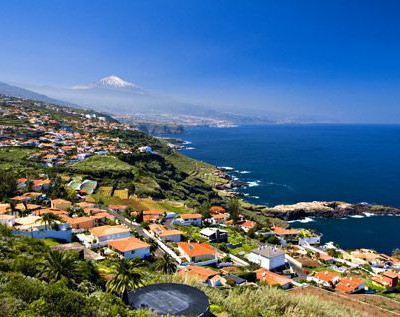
263;201;400;221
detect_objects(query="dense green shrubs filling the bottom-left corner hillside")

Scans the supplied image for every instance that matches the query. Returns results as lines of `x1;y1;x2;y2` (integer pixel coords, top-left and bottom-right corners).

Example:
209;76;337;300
0;226;147;317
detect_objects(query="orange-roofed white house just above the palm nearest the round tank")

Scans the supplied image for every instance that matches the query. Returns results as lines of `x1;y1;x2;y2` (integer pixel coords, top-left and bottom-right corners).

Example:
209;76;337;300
108;237;151;260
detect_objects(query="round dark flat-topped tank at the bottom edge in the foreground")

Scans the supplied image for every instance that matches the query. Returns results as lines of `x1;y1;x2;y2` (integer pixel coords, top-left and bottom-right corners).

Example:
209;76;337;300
127;283;210;317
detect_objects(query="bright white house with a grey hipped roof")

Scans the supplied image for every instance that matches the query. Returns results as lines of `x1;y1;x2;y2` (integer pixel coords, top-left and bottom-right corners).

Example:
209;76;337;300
246;245;285;270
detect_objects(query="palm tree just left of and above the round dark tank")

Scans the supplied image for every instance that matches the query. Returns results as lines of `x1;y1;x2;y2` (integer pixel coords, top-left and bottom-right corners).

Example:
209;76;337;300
107;259;144;297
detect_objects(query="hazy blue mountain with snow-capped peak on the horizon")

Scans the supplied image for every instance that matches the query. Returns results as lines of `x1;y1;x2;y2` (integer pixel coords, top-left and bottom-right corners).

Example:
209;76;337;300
4;75;330;124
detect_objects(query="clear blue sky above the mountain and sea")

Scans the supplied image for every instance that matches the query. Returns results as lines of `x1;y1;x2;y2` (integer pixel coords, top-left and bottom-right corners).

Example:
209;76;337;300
0;0;400;123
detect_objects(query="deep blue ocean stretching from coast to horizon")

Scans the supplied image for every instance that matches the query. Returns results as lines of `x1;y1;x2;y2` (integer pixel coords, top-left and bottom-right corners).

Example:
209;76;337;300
180;125;400;252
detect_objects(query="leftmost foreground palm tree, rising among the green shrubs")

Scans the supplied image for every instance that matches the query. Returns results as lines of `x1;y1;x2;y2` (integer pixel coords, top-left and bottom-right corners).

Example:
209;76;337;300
39;251;78;282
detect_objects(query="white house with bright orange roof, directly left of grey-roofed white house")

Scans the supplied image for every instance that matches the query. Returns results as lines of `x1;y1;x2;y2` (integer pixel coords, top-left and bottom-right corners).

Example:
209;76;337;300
178;241;217;263
